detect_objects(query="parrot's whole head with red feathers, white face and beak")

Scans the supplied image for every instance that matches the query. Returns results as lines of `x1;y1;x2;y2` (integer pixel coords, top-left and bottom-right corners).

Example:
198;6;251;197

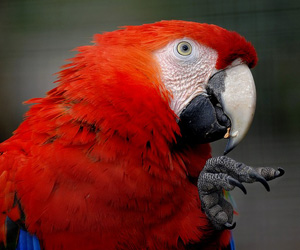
56;21;257;153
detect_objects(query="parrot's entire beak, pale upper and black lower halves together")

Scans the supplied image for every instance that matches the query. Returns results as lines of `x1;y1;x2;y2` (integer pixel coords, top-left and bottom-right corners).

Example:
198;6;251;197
178;64;256;154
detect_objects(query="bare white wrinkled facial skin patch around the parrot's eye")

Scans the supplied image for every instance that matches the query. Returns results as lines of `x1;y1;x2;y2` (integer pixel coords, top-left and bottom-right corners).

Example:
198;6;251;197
154;38;218;116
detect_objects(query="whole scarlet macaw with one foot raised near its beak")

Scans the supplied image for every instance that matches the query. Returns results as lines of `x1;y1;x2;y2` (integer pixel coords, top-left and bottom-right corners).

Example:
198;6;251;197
0;20;284;250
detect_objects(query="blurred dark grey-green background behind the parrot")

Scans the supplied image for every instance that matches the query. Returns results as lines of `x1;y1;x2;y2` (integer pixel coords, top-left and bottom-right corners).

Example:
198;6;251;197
0;0;300;250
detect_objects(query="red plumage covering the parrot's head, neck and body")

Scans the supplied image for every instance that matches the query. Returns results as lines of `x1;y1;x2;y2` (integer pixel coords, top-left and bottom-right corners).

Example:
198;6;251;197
0;21;257;250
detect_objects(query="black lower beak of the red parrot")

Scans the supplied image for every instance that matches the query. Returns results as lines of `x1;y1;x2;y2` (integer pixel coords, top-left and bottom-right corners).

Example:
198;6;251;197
178;94;231;144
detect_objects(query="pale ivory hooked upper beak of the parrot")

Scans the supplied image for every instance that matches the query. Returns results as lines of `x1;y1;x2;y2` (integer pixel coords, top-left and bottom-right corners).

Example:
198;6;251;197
208;64;256;154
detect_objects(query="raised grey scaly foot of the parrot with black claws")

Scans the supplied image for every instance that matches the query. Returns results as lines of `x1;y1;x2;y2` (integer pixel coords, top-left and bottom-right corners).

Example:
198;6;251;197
197;156;284;230
